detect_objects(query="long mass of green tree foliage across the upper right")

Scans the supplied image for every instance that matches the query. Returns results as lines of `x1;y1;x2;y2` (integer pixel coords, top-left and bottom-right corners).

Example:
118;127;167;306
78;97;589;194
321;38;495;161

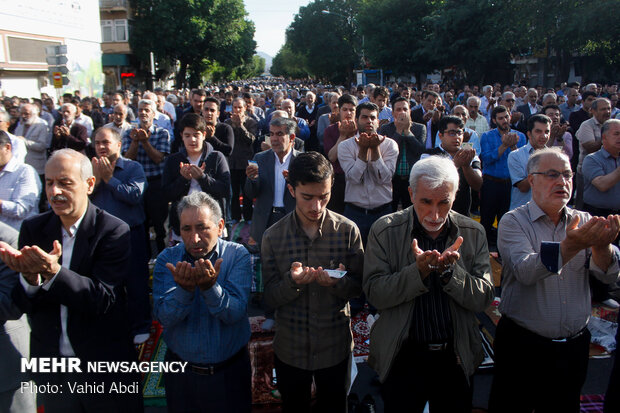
280;0;620;82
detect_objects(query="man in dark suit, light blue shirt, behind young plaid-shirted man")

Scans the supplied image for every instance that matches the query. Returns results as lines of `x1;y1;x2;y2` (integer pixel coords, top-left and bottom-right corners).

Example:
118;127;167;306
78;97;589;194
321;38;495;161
245;118;299;244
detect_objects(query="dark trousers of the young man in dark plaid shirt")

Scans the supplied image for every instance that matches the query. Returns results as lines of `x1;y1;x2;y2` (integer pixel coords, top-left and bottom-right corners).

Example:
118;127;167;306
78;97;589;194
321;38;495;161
273;355;349;413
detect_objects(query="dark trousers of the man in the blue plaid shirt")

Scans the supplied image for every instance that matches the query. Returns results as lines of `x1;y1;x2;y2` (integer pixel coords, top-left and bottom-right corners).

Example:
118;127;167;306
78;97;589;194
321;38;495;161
144;176;168;256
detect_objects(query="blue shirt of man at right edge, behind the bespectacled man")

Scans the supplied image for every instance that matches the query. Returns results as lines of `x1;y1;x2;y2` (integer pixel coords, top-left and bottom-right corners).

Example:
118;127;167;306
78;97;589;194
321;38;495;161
581;148;620;210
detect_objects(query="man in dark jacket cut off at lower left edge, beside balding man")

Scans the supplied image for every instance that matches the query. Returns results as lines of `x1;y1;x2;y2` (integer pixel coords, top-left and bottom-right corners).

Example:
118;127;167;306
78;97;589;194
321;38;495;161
0;222;36;413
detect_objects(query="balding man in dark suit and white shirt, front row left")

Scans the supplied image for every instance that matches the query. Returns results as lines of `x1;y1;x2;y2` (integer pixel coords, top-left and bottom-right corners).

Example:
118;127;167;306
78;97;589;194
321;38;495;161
0;149;143;413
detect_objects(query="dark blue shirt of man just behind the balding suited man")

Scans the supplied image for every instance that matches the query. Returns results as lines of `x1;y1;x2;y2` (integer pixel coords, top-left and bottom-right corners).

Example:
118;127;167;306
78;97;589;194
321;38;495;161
90;156;146;227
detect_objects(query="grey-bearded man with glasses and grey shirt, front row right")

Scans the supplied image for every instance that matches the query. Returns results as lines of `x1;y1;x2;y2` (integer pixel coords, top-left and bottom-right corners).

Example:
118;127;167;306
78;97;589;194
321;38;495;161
489;148;620;412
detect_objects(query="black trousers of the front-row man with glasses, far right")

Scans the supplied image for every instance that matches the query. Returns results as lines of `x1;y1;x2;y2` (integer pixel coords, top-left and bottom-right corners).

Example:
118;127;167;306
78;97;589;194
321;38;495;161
489;316;590;413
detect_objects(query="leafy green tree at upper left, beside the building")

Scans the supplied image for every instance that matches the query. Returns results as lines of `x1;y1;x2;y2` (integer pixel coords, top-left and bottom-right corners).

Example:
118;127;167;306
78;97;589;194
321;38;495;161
130;0;256;87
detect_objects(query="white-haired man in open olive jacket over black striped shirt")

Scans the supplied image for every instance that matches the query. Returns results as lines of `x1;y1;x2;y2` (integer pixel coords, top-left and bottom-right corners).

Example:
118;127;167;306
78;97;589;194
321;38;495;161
363;156;494;413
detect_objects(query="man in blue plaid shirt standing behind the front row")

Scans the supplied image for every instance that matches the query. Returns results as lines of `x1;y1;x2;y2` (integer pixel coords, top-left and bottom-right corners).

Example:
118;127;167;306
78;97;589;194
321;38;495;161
122;99;170;253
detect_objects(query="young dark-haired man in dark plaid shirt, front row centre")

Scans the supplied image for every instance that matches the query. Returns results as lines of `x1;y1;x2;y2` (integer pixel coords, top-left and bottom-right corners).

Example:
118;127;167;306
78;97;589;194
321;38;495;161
261;152;363;413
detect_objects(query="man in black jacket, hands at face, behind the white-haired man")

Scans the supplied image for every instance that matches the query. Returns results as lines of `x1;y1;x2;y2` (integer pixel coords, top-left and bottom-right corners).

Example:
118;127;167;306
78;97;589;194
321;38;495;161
378;96;426;212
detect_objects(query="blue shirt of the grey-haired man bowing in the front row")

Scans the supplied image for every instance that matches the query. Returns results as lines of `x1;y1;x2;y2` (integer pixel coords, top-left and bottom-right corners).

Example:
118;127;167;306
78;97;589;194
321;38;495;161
153;239;252;364
